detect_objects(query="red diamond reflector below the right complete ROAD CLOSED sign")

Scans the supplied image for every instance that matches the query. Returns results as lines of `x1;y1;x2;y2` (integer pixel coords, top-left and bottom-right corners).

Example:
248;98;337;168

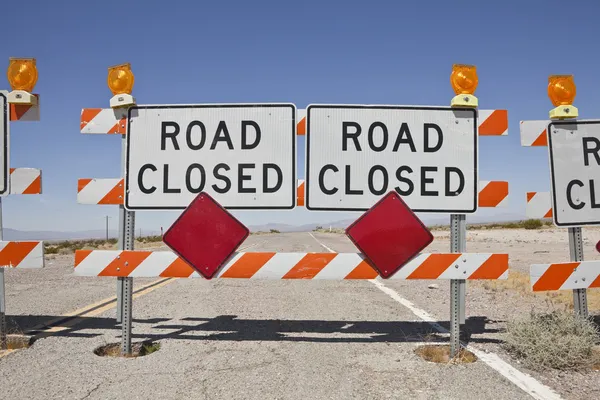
346;191;433;278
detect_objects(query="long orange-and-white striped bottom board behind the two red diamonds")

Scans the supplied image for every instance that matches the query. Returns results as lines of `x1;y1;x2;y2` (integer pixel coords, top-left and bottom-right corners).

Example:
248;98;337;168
75;250;508;280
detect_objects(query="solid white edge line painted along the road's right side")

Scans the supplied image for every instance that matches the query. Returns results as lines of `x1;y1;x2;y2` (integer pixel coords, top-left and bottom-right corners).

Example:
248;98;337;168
309;233;563;400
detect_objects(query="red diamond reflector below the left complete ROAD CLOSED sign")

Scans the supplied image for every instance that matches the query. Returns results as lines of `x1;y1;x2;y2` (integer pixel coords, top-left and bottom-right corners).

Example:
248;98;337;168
163;192;250;279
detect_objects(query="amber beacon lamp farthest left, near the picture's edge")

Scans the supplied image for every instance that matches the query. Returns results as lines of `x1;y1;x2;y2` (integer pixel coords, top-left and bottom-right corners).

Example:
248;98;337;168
6;57;38;105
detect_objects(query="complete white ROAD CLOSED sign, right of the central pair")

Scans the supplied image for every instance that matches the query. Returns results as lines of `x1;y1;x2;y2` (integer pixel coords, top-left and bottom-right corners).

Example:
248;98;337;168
306;105;478;214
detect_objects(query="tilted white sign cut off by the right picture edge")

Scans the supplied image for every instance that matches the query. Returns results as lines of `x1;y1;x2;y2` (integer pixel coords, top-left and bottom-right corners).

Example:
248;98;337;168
547;121;600;227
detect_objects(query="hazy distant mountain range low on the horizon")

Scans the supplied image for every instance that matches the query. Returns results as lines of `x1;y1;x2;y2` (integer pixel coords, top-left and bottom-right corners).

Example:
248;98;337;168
4;213;524;241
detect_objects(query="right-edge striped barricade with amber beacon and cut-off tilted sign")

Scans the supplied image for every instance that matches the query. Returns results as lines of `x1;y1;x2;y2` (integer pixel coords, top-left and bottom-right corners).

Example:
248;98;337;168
520;75;600;317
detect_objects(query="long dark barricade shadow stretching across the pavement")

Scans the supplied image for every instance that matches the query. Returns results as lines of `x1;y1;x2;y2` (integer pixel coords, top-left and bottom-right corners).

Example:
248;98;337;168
9;315;502;343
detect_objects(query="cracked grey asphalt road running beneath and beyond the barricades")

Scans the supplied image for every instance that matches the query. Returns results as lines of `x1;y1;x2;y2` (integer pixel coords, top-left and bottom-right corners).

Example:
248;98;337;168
0;233;556;399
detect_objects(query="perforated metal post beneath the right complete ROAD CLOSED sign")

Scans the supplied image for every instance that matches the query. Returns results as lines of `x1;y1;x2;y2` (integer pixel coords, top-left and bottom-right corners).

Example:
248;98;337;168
450;214;467;357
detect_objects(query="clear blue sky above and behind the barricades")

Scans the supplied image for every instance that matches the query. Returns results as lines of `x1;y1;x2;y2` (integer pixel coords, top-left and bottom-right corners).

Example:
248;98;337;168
0;0;600;232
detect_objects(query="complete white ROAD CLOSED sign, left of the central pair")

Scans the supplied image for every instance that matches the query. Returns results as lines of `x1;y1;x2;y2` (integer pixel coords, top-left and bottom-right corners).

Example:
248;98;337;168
125;104;296;210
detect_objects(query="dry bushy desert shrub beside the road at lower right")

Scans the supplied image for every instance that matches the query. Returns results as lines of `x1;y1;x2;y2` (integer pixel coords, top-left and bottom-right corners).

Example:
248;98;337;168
504;311;600;370
